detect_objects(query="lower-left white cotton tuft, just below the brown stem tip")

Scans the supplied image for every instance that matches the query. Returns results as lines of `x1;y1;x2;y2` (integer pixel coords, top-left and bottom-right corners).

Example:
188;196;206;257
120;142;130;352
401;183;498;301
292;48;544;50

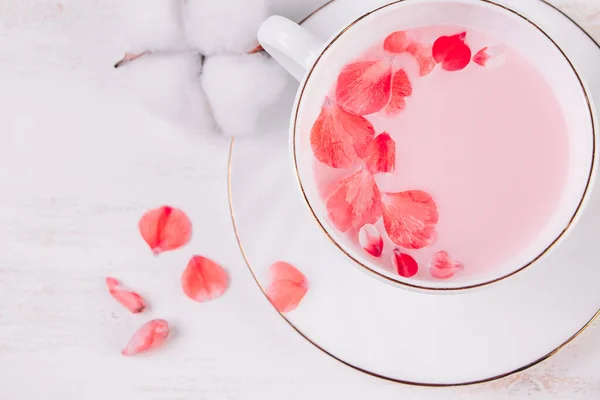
118;54;217;133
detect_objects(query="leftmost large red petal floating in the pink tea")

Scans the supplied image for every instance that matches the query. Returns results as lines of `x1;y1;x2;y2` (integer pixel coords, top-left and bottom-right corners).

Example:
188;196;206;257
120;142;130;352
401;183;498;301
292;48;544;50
310;98;375;168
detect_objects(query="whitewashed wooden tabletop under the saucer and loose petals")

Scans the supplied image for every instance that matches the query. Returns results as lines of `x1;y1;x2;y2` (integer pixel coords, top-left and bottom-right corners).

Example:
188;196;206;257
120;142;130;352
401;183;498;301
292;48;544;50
0;0;600;400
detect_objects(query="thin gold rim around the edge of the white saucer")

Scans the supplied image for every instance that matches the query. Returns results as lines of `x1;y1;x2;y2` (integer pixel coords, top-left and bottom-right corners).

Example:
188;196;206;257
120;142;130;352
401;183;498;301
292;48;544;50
227;0;600;387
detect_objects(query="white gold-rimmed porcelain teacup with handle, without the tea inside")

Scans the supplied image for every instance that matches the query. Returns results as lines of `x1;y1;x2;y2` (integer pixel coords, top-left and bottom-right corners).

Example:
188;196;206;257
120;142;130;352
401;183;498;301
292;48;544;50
258;0;595;291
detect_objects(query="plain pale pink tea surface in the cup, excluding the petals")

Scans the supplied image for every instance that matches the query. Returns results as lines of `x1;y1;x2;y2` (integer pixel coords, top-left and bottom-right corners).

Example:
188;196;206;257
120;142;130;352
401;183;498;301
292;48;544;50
315;27;569;279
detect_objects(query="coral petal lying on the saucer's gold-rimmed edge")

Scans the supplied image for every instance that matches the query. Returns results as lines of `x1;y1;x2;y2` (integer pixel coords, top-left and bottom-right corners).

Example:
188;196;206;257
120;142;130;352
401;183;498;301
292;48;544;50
267;261;308;312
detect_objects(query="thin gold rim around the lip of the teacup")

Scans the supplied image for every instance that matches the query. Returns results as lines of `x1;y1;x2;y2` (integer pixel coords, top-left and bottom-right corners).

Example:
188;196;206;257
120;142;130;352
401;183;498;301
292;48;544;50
292;0;596;292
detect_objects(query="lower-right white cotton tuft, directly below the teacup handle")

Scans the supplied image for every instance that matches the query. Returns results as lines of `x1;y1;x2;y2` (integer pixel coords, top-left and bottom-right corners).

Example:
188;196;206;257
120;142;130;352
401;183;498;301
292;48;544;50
202;54;288;136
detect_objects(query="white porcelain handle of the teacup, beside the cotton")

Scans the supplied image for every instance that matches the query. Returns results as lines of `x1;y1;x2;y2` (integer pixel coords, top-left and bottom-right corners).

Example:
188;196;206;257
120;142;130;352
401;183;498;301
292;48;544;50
257;15;323;81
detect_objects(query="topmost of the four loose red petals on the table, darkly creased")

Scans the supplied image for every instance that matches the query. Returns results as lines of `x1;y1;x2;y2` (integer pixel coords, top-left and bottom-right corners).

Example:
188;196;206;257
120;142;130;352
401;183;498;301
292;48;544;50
139;206;192;254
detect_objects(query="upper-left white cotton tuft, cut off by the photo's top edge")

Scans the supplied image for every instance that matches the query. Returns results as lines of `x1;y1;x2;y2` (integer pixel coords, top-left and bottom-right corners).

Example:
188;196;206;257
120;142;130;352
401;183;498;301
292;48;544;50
121;0;187;53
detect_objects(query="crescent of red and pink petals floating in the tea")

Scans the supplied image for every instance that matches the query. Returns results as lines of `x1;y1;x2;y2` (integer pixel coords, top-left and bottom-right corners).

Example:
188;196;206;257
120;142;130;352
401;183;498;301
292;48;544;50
310;30;504;279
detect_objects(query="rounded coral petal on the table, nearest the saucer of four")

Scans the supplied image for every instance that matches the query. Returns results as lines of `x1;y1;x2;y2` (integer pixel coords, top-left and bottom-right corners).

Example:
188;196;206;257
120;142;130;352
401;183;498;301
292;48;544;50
181;256;229;303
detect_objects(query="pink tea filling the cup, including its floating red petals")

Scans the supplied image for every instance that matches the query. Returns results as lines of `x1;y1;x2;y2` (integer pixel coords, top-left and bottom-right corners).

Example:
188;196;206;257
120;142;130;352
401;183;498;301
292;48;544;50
310;26;569;280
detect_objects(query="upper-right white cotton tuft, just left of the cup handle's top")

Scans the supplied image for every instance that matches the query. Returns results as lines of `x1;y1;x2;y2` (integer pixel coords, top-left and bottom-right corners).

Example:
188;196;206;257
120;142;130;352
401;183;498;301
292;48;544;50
182;0;267;55
